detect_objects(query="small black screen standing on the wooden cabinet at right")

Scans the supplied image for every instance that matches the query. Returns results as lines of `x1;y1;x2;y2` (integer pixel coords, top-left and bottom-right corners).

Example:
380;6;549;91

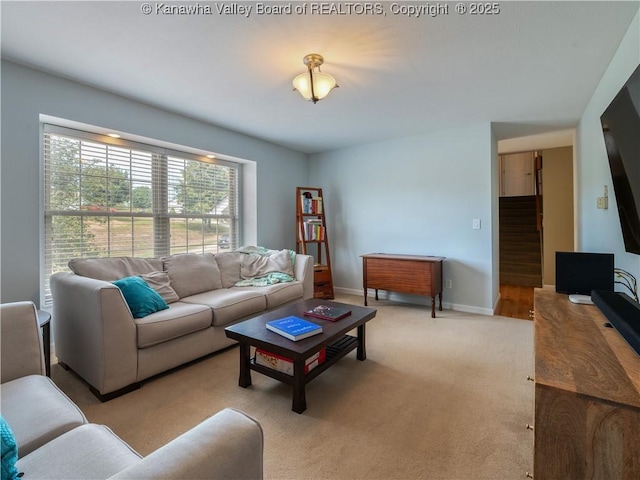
556;252;615;295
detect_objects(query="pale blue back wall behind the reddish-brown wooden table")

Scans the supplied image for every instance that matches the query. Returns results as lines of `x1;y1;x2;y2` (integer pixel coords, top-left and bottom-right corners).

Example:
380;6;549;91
310;123;497;313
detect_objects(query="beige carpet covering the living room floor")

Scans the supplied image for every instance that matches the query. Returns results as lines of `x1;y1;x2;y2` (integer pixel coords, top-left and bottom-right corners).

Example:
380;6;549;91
52;296;533;480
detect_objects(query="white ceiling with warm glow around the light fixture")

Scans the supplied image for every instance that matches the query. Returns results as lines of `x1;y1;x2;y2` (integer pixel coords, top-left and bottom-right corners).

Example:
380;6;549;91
0;0;640;153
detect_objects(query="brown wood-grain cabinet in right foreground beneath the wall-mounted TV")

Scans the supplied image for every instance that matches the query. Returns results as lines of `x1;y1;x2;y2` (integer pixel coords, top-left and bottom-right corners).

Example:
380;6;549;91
533;288;640;480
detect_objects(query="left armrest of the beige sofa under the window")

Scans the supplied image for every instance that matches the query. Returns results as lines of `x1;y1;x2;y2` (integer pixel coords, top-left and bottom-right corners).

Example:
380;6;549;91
51;272;138;395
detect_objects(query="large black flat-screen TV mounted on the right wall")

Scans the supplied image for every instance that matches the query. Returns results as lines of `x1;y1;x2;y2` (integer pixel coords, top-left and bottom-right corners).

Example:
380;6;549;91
600;65;640;254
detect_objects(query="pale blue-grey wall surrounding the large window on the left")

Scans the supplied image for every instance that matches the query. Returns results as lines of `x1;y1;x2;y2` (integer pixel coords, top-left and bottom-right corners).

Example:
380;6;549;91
0;61;308;305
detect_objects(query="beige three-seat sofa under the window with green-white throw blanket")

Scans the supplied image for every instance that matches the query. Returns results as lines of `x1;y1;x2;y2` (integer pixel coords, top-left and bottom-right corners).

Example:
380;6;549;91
51;248;313;401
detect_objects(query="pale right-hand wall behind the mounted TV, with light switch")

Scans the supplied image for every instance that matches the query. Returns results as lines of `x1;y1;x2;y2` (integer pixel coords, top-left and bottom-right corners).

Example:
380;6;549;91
574;13;640;277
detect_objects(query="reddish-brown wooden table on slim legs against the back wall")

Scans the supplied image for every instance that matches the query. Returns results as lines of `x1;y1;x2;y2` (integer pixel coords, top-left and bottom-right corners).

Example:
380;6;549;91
362;253;445;318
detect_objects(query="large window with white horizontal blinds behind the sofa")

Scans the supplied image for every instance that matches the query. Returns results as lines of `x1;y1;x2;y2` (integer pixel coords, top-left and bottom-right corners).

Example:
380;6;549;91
43;125;240;305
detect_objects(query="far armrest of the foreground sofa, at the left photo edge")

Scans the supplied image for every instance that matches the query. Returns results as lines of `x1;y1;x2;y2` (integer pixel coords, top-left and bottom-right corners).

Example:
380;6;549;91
0;302;45;383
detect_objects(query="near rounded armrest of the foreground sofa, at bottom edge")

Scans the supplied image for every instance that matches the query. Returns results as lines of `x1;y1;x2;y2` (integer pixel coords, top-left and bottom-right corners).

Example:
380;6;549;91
111;408;264;480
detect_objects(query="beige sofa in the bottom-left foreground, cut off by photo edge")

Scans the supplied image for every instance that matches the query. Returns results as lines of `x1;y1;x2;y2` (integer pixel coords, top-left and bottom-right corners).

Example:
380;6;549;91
0;302;264;480
